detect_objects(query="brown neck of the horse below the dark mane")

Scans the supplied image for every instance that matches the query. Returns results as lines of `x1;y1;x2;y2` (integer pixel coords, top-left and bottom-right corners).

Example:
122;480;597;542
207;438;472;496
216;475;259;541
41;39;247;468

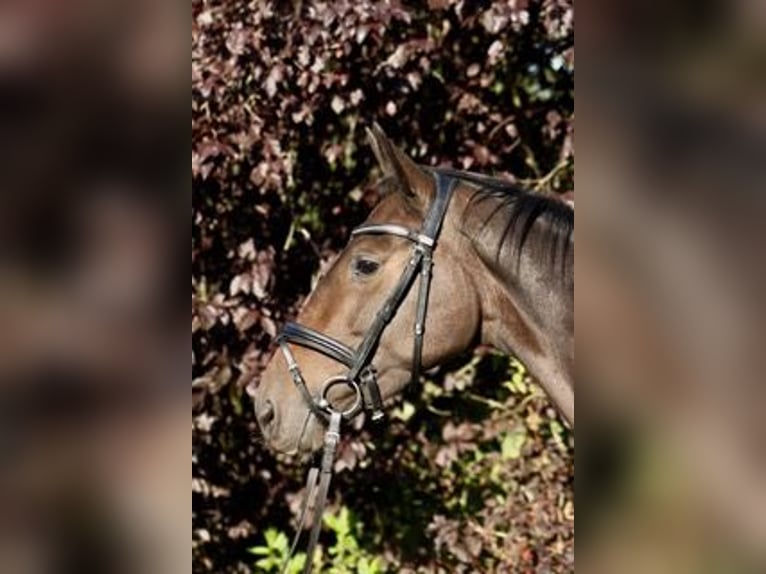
456;184;574;410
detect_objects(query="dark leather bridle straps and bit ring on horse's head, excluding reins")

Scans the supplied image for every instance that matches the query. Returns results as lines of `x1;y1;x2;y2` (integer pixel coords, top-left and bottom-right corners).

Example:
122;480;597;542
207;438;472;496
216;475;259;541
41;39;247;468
277;170;457;422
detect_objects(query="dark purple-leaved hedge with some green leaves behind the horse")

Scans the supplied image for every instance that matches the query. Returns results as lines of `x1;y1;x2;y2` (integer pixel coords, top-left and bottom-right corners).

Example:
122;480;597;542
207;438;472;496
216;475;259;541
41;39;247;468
192;0;574;573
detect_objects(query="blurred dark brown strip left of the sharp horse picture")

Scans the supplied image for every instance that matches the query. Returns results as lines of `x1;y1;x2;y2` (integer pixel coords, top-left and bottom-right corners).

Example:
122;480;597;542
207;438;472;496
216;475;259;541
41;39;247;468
0;0;190;574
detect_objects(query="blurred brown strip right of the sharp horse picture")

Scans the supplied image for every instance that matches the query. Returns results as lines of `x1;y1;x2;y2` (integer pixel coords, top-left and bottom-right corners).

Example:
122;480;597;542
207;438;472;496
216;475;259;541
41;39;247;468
575;0;766;574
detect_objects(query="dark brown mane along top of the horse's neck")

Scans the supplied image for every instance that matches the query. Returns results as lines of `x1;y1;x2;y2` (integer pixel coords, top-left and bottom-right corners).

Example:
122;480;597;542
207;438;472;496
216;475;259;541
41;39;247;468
432;168;574;277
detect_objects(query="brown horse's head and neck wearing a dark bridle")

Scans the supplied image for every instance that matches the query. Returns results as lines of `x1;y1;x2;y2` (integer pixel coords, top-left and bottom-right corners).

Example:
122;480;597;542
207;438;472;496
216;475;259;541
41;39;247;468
253;124;574;455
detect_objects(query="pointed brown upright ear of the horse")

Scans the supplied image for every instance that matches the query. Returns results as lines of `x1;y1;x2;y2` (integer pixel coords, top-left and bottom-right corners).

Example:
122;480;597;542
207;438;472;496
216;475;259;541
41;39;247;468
367;122;434;208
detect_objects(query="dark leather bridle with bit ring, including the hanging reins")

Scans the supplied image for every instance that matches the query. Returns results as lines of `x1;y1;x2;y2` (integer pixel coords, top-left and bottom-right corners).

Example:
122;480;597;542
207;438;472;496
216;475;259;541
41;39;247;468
277;169;458;574
